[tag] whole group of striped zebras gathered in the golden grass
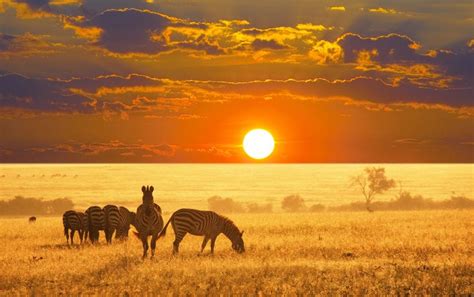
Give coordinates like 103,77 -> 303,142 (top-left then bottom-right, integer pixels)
63,186 -> 245,258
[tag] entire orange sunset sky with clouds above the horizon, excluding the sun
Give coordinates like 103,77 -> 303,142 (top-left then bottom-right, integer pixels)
0,0 -> 474,162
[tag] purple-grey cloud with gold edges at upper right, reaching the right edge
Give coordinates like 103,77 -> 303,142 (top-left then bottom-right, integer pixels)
337,33 -> 474,88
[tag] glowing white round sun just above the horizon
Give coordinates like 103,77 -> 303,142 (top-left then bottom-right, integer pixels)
243,129 -> 275,160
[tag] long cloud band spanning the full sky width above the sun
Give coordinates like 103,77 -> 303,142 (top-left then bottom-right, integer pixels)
0,74 -> 473,119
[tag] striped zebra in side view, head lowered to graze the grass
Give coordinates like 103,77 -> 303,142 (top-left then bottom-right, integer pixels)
158,208 -> 245,254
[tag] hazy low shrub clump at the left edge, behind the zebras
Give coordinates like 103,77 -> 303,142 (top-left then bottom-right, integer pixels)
0,196 -> 74,215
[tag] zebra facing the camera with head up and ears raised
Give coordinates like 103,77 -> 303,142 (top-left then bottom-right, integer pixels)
134,186 -> 163,258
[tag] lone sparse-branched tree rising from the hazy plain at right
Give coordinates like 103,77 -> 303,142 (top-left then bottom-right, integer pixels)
351,167 -> 395,212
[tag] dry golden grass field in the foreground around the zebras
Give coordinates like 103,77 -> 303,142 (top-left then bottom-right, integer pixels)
0,211 -> 474,296
